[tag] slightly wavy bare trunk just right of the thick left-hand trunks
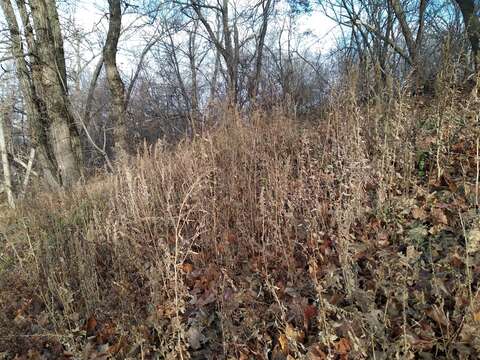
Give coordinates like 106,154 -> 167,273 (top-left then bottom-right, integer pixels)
103,0 -> 128,156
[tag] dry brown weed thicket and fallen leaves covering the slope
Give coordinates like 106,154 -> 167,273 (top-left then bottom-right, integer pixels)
0,74 -> 480,359
